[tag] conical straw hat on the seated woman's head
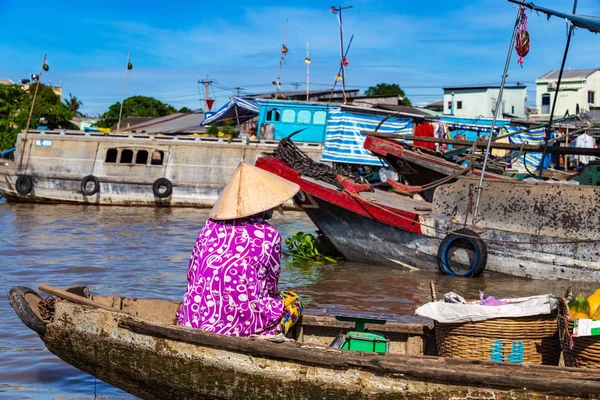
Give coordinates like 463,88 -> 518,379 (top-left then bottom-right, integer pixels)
210,162 -> 300,220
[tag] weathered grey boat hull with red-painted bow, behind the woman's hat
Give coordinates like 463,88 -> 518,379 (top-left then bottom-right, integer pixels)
256,153 -> 600,281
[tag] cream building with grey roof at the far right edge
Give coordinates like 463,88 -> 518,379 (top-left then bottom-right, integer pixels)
535,68 -> 600,116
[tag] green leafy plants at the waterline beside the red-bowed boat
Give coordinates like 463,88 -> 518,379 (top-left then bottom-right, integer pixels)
285,231 -> 344,264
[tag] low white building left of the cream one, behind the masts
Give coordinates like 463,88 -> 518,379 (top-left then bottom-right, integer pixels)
444,85 -> 527,118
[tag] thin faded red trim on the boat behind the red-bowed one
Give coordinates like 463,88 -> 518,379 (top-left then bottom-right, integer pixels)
364,136 -> 513,180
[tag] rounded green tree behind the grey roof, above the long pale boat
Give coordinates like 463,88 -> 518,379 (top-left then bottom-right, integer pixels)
96,96 -> 176,128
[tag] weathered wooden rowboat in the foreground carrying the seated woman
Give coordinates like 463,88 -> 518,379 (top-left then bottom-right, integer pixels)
9,287 -> 600,400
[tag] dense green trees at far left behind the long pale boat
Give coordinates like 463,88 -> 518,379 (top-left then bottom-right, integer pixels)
0,83 -> 73,150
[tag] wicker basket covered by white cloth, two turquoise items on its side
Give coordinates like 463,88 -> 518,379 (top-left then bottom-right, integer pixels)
435,315 -> 560,365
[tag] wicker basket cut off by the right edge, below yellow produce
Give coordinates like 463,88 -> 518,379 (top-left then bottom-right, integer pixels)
558,299 -> 600,369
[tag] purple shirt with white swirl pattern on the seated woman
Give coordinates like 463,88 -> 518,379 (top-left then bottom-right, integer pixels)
177,217 -> 283,336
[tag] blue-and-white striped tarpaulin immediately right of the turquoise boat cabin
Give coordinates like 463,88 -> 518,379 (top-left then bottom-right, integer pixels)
323,109 -> 413,166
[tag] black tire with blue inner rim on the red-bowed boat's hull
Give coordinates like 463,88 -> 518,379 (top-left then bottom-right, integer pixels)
437,228 -> 488,278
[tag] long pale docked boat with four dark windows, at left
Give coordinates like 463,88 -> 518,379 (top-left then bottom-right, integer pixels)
0,131 -> 323,207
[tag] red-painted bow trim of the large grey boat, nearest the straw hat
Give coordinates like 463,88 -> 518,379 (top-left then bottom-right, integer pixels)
256,156 -> 423,234
